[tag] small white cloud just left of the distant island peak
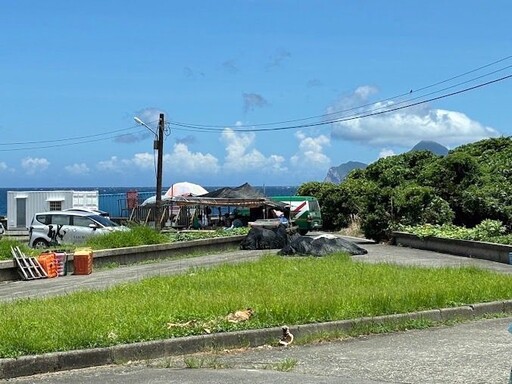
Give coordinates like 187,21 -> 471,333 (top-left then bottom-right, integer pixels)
290,131 -> 331,167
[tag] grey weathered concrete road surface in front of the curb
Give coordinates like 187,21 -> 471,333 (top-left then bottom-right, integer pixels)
7,318 -> 512,384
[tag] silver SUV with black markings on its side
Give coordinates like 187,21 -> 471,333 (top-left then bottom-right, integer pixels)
28,211 -> 128,248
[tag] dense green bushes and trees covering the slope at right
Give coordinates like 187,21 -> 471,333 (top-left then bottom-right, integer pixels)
297,137 -> 512,241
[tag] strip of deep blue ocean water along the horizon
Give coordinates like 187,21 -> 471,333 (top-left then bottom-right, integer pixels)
0,186 -> 298,216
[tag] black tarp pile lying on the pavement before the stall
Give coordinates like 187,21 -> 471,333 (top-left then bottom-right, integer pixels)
240,225 -> 368,256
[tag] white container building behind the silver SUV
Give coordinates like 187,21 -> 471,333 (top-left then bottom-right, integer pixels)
7,190 -> 99,230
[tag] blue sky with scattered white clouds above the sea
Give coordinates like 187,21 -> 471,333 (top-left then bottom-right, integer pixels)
0,0 -> 512,188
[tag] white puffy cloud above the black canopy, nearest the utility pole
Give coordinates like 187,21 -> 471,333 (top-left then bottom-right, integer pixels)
221,128 -> 287,173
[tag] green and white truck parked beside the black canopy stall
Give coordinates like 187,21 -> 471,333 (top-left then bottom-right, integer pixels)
270,196 -> 322,235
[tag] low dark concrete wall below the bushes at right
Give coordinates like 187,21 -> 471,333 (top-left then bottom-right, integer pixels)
392,232 -> 512,264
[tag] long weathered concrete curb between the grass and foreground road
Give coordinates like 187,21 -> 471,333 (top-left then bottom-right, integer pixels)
0,300 -> 512,379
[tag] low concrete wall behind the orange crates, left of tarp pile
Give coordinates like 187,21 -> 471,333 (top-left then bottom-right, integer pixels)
0,235 -> 245,281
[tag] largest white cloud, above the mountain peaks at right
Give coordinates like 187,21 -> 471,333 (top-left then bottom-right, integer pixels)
328,87 -> 499,147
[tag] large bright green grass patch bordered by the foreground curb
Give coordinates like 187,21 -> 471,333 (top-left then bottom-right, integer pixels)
0,254 -> 512,357
